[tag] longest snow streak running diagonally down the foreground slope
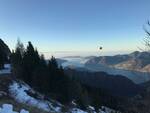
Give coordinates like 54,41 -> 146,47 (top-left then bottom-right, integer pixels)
9,82 -> 61,112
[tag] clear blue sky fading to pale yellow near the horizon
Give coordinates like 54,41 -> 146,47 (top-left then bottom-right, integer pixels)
0,0 -> 150,57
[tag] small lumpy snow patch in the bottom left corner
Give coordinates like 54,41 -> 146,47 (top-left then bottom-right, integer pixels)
0,104 -> 29,113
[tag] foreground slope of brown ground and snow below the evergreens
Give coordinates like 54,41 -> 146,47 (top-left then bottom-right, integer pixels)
0,75 -> 120,113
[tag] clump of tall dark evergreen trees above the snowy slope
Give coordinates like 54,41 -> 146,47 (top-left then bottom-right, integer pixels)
11,41 -> 81,103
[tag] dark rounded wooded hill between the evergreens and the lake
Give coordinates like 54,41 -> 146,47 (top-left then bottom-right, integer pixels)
66,69 -> 143,96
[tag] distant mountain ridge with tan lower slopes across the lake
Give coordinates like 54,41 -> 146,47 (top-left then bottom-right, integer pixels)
86,51 -> 150,72
